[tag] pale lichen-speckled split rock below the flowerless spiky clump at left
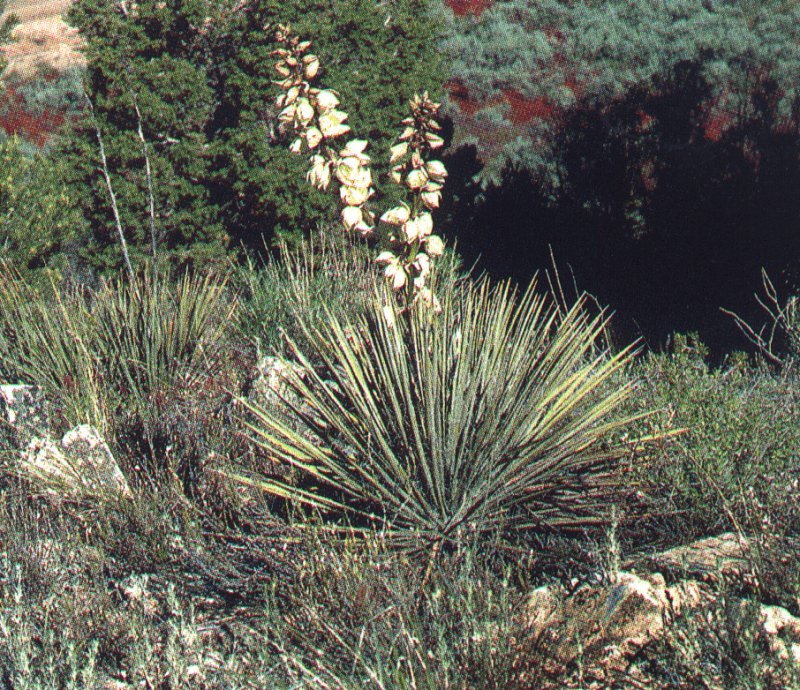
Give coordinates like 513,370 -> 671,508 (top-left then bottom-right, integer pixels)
21,424 -> 131,499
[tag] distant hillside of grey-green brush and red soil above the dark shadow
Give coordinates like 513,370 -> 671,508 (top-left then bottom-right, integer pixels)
443,0 -> 800,188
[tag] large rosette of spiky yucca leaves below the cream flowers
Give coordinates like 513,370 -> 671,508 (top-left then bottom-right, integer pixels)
237,281 -> 630,551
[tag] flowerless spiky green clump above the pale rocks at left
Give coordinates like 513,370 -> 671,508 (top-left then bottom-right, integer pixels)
0,266 -> 236,438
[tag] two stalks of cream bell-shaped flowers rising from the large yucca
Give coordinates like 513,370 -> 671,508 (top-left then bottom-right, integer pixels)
272,25 -> 447,312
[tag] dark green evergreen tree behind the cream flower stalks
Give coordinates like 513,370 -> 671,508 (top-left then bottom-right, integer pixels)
58,0 -> 444,270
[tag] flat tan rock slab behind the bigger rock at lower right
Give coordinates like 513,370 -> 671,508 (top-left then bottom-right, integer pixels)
636,532 -> 750,582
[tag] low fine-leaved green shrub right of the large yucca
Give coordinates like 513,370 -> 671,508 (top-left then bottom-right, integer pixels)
630,336 -> 800,541
